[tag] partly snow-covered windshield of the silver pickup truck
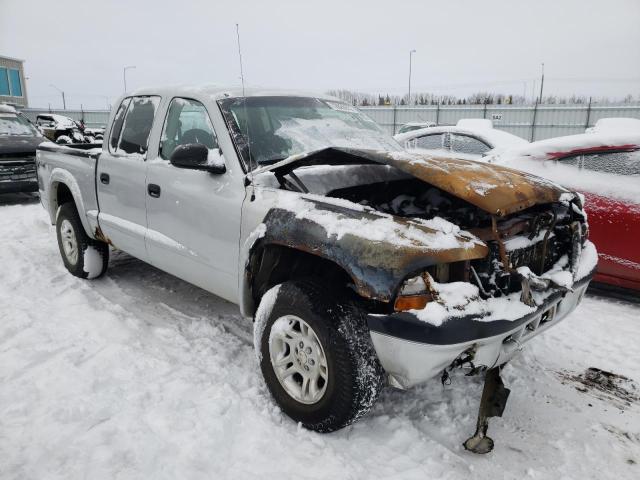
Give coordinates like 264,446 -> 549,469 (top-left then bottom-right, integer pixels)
219,96 -> 401,169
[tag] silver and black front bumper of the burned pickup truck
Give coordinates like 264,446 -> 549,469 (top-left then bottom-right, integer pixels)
367,269 -> 595,388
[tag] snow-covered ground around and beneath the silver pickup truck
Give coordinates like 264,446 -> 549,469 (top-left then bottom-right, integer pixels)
0,197 -> 640,480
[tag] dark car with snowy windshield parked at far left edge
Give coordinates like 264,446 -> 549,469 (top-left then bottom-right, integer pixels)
0,105 -> 46,194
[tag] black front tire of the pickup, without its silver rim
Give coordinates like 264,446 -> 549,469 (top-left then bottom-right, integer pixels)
254,280 -> 384,432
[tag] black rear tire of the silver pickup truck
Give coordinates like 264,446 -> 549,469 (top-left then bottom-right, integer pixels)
56,203 -> 109,279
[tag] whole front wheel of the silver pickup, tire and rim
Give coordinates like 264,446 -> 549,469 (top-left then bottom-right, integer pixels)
254,281 -> 383,432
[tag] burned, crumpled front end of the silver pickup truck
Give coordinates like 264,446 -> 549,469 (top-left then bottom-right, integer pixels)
248,148 -> 597,453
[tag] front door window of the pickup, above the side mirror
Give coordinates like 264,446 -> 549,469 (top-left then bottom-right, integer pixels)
160,98 -> 218,160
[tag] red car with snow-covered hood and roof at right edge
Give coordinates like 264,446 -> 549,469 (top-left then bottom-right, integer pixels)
488,125 -> 640,296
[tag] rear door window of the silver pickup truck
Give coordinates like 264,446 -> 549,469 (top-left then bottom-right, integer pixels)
112,96 -> 160,155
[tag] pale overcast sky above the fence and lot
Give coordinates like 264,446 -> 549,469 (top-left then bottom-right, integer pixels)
0,0 -> 640,108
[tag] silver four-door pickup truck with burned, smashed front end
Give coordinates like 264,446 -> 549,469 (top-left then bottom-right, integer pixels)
36,87 -> 597,451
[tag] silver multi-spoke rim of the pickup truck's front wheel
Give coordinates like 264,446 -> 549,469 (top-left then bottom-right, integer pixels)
269,315 -> 329,405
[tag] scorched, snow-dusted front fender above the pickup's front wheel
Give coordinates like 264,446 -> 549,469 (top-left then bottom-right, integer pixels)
245,198 -> 488,316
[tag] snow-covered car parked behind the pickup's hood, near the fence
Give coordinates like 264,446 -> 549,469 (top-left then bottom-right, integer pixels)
394,118 -> 529,160
